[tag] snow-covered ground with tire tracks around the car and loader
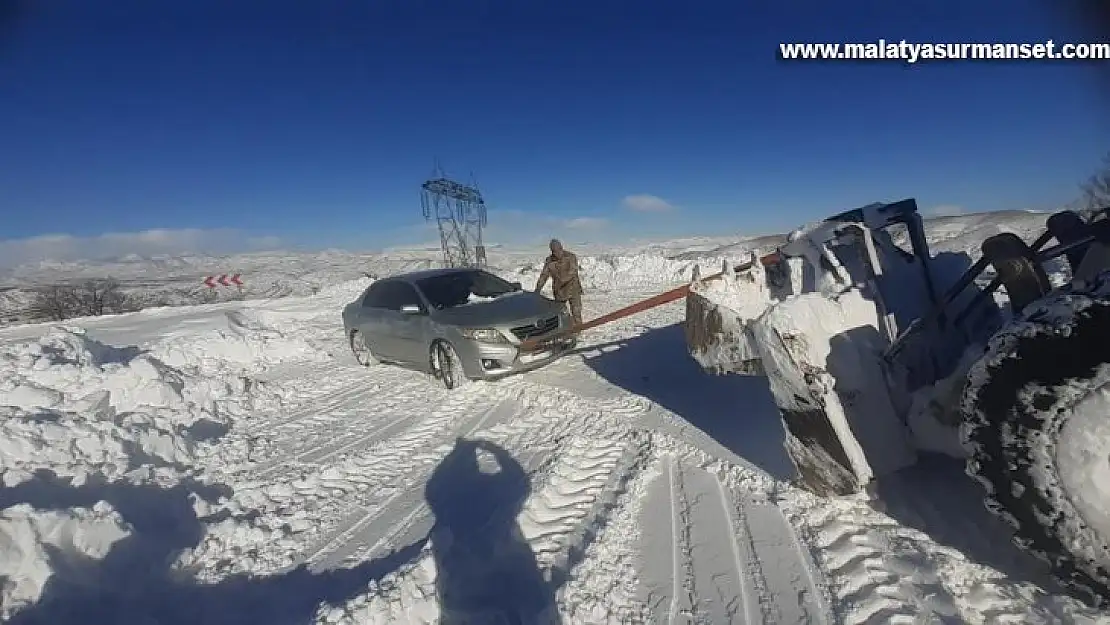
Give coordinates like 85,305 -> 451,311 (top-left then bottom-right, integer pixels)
0,213 -> 1110,625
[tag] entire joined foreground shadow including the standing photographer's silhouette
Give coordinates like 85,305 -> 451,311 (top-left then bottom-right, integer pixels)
0,438 -> 558,625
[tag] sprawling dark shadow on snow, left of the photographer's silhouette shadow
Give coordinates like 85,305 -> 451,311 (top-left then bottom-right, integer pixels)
0,474 -> 423,625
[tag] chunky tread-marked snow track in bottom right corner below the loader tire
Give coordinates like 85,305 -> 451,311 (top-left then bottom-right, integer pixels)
794,484 -> 1110,625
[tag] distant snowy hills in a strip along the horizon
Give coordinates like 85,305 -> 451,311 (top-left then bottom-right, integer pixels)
0,211 -> 1043,327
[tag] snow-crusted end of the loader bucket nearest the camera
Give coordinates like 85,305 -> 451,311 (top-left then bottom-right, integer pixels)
748,289 -> 917,495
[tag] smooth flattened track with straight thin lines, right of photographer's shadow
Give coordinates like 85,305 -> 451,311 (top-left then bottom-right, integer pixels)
639,444 -> 829,625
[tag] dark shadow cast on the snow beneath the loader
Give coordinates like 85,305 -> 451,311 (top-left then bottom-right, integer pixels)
576,324 -> 1063,594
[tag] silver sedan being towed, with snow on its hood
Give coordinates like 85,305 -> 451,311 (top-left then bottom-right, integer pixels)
343,269 -> 574,389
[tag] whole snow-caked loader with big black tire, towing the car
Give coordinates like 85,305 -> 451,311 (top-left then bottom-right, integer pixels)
686,199 -> 1110,605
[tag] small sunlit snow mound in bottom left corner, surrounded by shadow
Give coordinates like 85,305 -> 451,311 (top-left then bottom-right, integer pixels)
0,502 -> 131,619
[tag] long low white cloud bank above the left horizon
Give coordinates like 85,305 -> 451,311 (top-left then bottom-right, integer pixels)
0,228 -> 281,266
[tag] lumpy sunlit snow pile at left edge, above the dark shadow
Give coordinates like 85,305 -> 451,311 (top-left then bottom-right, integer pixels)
0,329 -> 275,486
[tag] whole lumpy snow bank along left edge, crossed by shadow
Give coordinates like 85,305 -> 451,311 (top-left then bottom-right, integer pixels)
0,327 -> 295,617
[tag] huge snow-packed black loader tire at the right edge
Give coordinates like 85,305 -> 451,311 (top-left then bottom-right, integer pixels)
960,273 -> 1110,607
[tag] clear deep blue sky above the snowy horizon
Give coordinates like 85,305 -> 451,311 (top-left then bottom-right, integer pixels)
0,0 -> 1110,261
